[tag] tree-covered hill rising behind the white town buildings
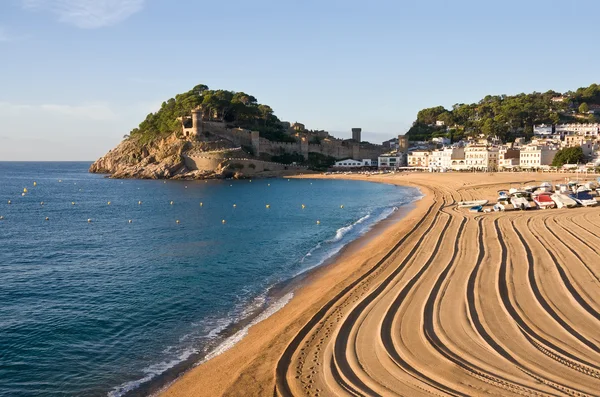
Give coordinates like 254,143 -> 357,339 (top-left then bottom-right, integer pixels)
407,84 -> 600,141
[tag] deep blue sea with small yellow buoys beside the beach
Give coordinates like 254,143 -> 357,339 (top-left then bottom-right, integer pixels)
0,162 -> 420,396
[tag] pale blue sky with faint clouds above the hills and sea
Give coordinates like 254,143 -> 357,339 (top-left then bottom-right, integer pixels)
0,0 -> 600,160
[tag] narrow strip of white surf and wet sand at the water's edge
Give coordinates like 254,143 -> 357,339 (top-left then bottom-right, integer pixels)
122,180 -> 424,397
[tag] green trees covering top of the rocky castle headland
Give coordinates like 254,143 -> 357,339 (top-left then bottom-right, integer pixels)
130,84 -> 293,143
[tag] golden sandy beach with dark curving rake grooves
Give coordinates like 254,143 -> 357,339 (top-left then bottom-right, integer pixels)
162,173 -> 600,397
